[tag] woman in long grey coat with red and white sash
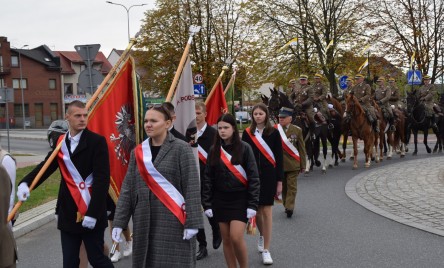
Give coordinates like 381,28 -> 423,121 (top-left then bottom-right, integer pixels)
112,106 -> 203,267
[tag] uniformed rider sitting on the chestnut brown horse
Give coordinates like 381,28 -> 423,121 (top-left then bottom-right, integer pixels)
350,74 -> 379,133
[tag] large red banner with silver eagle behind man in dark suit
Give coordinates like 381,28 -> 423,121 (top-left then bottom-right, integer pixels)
88,57 -> 144,201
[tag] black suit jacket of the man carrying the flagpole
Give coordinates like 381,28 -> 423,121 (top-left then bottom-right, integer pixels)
20,129 -> 110,233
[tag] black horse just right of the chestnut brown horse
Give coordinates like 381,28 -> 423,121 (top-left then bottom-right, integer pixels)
407,90 -> 442,155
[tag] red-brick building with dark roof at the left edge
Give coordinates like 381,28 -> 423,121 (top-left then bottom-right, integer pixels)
0,37 -> 62,128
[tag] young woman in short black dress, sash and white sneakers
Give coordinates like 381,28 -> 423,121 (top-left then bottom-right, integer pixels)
242,103 -> 284,264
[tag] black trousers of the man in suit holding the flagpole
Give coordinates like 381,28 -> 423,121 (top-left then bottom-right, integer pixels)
60,229 -> 114,268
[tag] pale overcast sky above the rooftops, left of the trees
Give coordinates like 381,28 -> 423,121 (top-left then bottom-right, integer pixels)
0,0 -> 155,57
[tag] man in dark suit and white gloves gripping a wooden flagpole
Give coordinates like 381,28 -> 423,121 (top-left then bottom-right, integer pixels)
17,101 -> 114,267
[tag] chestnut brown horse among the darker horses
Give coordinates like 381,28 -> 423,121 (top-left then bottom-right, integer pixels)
345,94 -> 377,169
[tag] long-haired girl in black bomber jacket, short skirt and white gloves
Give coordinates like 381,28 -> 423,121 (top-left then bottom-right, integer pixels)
202,114 -> 260,268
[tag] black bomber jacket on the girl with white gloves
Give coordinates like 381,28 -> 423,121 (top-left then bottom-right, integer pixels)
202,141 -> 260,211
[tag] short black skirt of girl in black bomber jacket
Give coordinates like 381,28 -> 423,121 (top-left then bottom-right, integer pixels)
213,191 -> 248,223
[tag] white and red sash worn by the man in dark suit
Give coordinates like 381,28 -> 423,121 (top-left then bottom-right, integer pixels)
57,135 -> 93,216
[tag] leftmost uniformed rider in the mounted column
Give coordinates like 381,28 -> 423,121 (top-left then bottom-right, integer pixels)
290,74 -> 316,138
